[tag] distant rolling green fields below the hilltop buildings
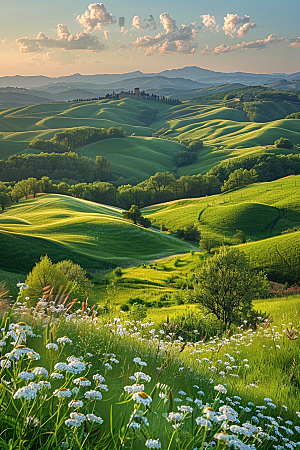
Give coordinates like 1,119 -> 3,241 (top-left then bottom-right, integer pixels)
0,99 -> 300,181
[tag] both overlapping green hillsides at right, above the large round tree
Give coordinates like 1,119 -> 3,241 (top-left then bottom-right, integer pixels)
143,176 -> 300,281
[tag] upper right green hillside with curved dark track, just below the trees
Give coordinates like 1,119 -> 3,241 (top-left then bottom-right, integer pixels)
143,176 -> 300,240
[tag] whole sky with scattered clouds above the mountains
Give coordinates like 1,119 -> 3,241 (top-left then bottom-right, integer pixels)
0,0 -> 300,77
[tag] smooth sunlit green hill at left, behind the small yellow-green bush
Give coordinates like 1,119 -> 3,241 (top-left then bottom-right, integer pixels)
0,195 -> 196,272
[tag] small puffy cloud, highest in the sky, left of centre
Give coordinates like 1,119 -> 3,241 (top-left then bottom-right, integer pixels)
77,3 -> 116,33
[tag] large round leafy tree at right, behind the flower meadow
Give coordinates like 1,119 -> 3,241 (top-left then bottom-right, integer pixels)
194,246 -> 268,327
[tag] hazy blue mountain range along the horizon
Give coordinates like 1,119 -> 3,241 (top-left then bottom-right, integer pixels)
0,66 -> 300,109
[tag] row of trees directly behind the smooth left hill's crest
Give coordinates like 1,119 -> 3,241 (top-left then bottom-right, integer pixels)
0,172 -> 221,209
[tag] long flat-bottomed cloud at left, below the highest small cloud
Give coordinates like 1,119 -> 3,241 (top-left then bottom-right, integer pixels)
16,24 -> 105,53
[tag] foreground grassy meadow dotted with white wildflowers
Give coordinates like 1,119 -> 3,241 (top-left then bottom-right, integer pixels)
0,291 -> 300,450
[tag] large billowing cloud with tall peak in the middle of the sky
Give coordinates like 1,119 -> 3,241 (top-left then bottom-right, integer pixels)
132,13 -> 198,56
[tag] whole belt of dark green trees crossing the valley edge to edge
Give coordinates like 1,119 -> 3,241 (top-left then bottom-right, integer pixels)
0,152 -> 300,209
